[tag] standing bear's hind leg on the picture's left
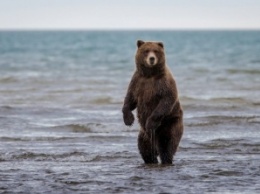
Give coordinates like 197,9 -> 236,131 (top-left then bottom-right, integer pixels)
138,130 -> 158,164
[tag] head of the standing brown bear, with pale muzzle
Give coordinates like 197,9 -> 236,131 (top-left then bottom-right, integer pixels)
135,40 -> 165,75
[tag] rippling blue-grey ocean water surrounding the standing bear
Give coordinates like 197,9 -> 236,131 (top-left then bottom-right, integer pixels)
0,31 -> 260,193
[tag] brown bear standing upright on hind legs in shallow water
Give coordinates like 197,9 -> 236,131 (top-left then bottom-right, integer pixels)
122,40 -> 183,164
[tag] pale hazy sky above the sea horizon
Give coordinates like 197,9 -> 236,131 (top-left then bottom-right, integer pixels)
0,0 -> 260,29
